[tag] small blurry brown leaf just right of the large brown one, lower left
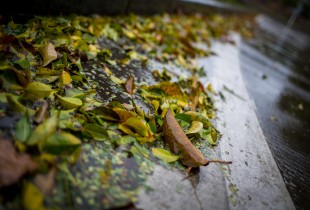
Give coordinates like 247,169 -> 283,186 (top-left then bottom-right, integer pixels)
34,167 -> 57,196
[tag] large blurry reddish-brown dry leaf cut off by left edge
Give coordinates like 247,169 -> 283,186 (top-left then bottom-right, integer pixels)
0,138 -> 38,187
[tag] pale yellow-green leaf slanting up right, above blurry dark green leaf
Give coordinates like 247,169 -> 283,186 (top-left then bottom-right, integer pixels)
27,115 -> 58,145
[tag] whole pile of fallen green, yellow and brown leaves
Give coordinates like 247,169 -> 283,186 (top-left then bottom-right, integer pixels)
0,15 -> 249,210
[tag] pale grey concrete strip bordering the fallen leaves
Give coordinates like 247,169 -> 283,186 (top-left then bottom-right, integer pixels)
137,35 -> 295,210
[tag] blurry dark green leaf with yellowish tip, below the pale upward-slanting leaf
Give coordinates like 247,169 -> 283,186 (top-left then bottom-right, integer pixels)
42,131 -> 81,155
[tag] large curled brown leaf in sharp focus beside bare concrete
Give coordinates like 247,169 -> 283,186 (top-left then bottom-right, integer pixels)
163,109 -> 208,167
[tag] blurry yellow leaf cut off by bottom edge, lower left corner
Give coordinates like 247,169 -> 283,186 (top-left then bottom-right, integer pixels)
23,182 -> 45,210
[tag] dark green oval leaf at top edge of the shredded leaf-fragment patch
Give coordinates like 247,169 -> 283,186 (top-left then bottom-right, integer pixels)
82,123 -> 109,141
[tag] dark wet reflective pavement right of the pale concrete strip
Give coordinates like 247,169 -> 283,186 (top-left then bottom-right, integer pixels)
240,15 -> 310,209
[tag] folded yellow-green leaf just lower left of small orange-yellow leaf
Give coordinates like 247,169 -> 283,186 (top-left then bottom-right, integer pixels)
24,82 -> 53,100
